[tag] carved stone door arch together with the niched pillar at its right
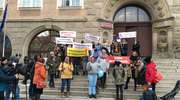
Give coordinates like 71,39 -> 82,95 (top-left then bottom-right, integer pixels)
100,0 -> 174,57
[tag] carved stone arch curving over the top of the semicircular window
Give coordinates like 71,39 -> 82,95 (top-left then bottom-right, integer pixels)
103,0 -> 171,20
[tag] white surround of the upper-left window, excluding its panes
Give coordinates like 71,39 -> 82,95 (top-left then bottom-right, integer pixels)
17,0 -> 43,10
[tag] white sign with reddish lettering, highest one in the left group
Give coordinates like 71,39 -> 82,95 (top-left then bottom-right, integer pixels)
60,31 -> 76,38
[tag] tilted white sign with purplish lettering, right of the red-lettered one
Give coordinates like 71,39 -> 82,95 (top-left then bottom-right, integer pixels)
85,33 -> 100,42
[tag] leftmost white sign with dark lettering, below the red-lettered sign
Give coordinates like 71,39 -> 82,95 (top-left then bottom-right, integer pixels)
56,37 -> 73,44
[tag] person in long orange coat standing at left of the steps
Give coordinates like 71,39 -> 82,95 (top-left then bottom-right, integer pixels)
33,58 -> 46,100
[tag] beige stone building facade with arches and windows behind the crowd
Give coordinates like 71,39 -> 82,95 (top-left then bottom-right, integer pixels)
0,0 -> 180,58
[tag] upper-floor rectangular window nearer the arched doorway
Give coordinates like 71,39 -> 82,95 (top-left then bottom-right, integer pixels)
57,0 -> 84,8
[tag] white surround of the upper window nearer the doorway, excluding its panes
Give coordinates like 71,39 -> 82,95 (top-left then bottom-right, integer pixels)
57,0 -> 84,9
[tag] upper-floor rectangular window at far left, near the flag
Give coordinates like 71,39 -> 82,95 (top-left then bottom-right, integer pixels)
18,0 -> 43,8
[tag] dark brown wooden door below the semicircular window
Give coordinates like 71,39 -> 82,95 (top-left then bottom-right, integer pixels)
114,23 -> 152,56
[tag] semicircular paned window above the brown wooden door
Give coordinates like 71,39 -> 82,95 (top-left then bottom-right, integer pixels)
114,6 -> 151,22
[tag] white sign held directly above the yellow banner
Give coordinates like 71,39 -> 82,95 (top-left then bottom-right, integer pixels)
73,43 -> 92,50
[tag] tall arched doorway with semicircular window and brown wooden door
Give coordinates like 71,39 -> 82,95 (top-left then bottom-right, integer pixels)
113,5 -> 152,56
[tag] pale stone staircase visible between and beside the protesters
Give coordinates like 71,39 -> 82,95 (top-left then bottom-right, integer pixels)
20,59 -> 180,100
